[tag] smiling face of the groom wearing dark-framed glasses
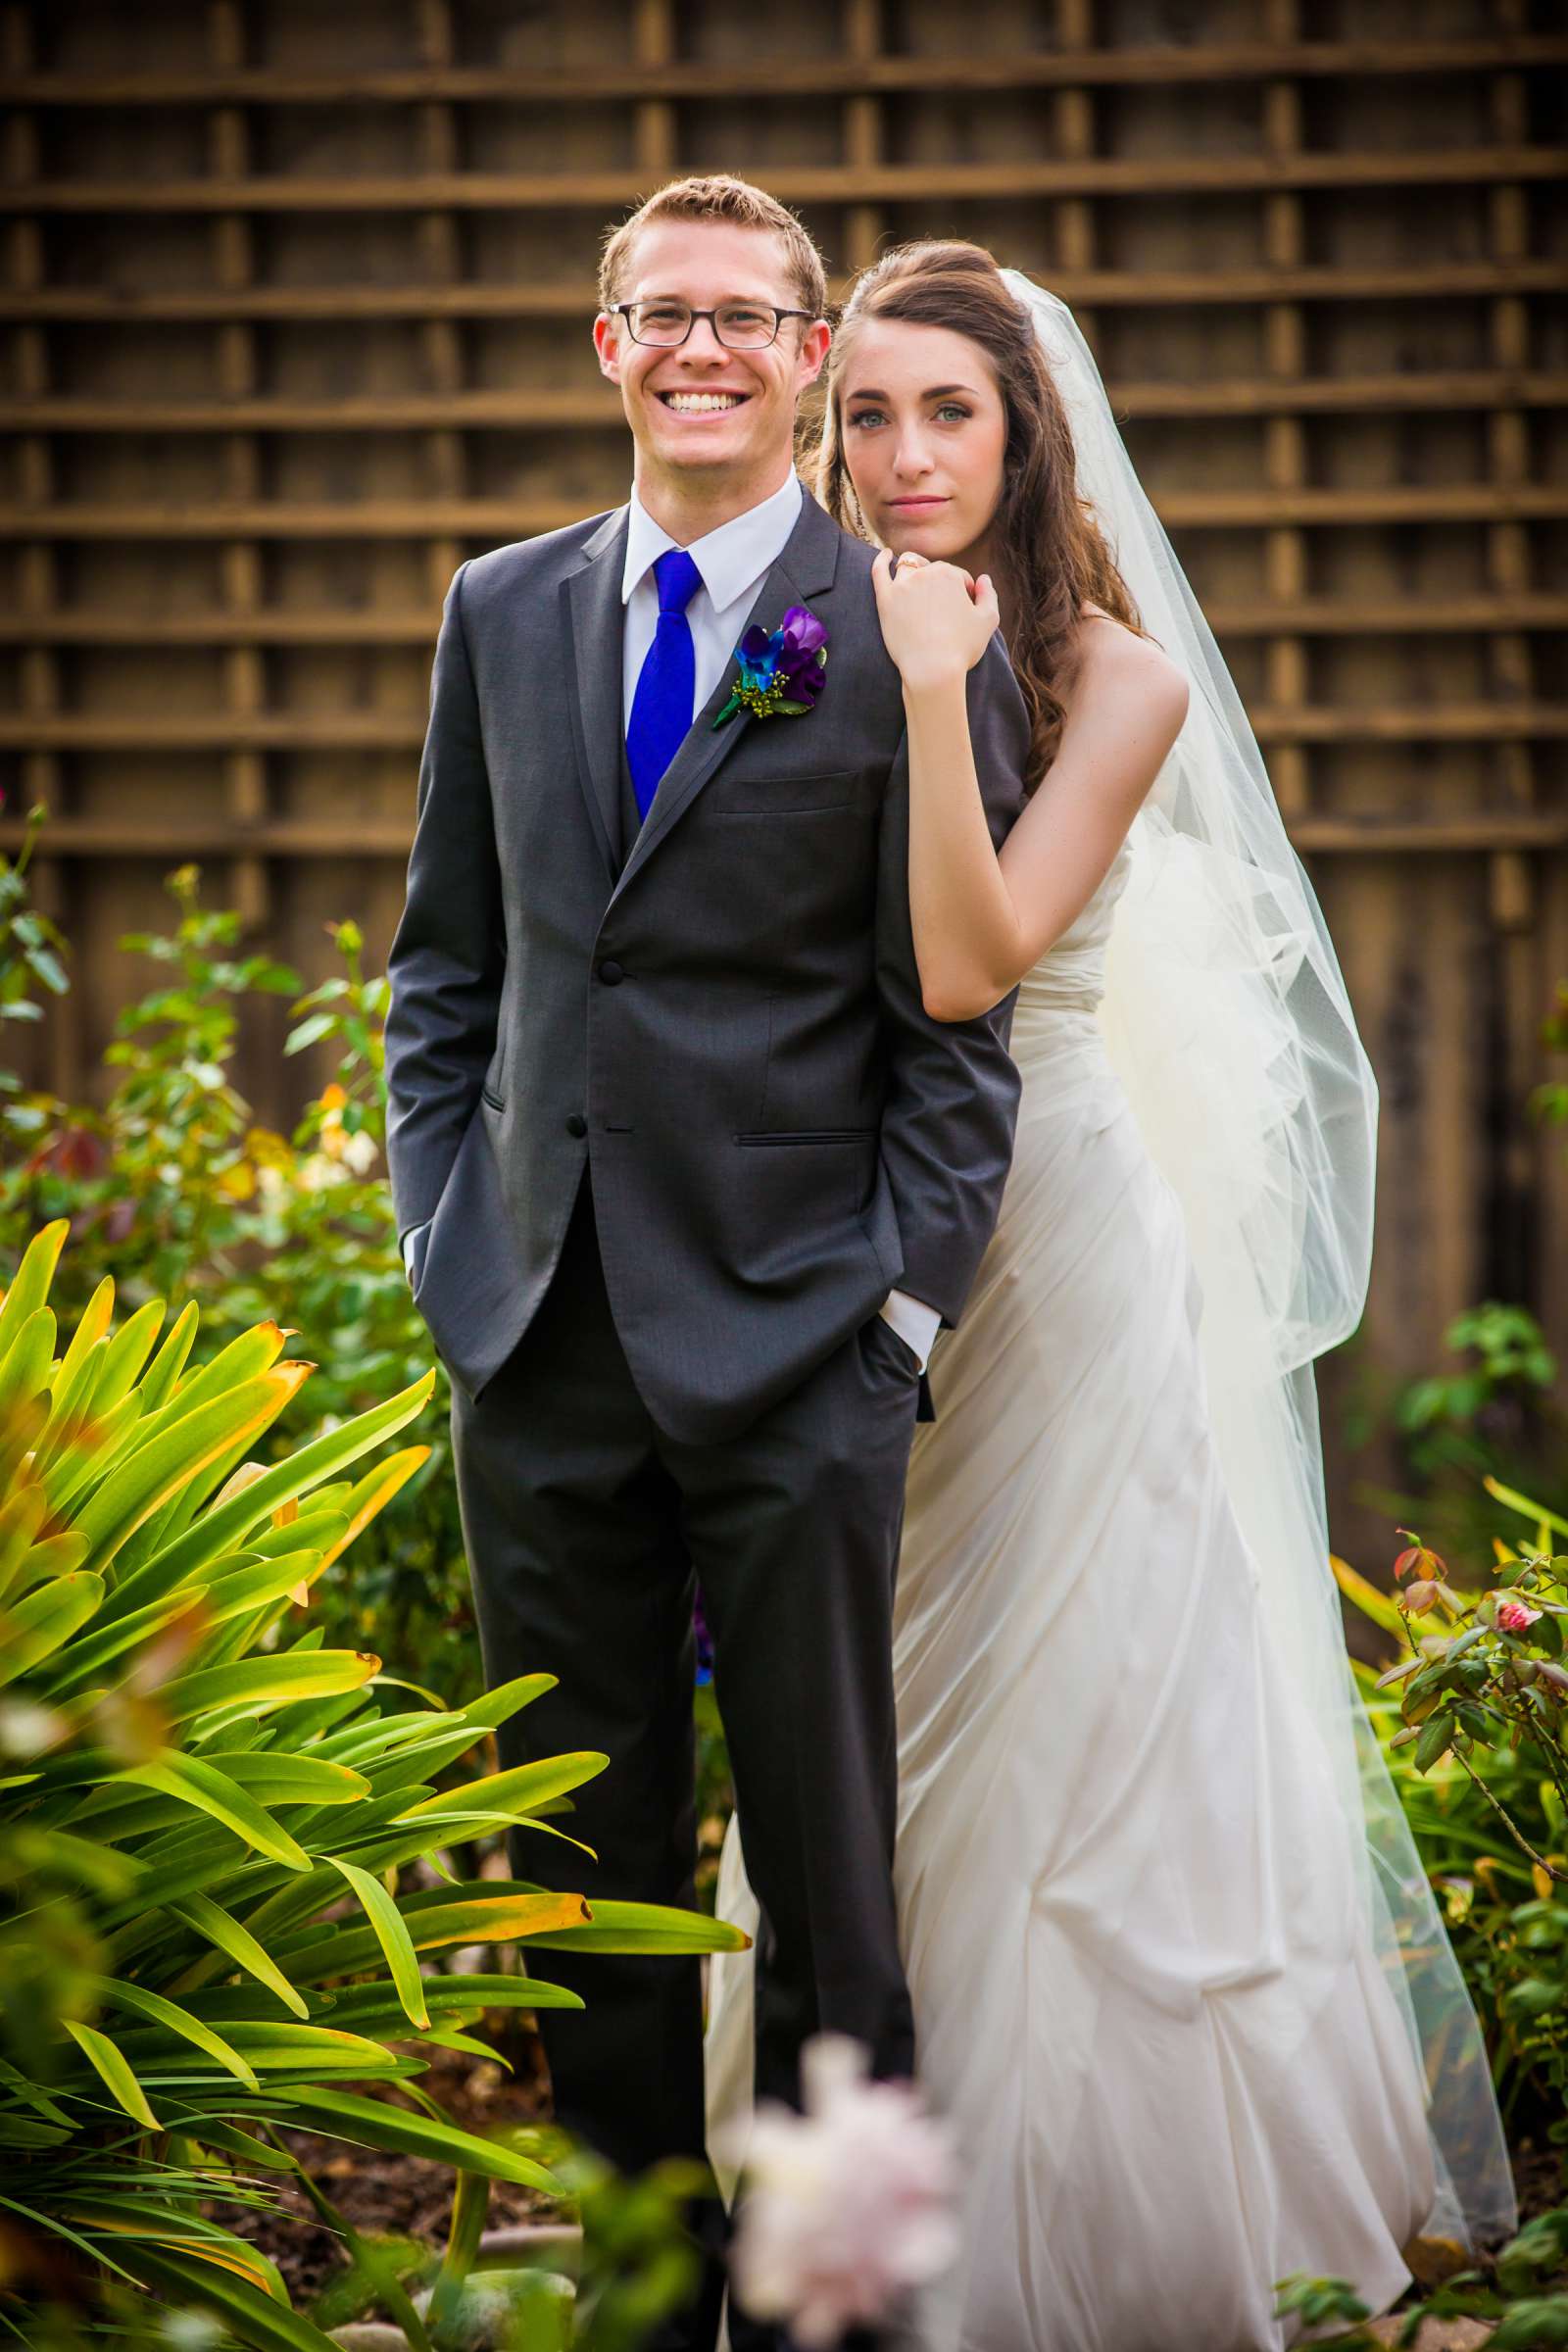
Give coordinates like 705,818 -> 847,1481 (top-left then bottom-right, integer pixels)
592,221 -> 830,482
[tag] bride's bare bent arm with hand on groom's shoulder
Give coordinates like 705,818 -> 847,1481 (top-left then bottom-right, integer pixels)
877,558 -> 1187,1021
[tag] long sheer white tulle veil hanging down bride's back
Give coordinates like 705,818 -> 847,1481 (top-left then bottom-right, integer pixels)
1002,270 -> 1514,2244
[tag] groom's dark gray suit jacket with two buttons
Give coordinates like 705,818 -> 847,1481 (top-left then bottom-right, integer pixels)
385,499 -> 1027,1445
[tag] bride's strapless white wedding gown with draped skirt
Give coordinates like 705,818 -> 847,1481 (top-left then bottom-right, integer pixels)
708,849 -> 1434,2352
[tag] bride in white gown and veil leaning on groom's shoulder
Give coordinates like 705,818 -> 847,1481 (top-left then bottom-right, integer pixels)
708,245 -> 1514,2352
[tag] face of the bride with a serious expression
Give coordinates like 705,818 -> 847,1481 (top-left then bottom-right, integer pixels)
839,318 -> 1006,569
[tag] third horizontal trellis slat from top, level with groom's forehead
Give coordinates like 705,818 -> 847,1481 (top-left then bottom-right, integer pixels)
0,259 -> 1563,324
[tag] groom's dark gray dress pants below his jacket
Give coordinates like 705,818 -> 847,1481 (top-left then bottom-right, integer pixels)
452,1178 -> 919,2352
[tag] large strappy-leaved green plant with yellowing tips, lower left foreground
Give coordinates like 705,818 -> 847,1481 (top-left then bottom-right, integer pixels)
0,1221 -> 738,2352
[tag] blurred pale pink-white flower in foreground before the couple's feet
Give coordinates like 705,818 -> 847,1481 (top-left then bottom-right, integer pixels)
731,2034 -> 959,2347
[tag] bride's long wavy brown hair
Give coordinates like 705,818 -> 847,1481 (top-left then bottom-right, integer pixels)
818,240 -> 1145,790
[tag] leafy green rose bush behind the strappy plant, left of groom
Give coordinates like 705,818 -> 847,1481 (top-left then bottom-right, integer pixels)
0,860 -> 479,1703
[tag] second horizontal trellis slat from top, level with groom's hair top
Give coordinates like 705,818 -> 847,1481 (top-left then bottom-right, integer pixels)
0,146 -> 1568,214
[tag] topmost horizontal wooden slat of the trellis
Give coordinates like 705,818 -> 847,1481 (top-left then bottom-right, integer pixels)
10,33 -> 1568,108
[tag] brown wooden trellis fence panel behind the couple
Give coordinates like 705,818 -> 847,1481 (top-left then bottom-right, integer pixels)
0,0 -> 1568,1534
